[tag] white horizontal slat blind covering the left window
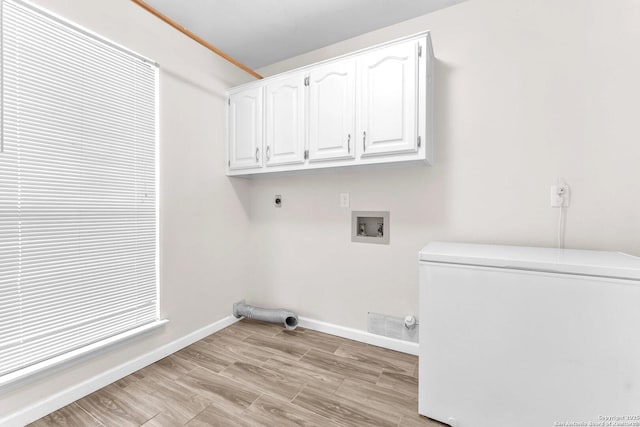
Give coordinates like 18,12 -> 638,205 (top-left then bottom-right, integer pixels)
0,0 -> 158,378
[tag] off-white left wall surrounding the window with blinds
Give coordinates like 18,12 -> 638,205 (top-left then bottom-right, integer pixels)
0,0 -> 255,424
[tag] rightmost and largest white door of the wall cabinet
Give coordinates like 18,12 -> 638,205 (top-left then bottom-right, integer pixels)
358,41 -> 418,157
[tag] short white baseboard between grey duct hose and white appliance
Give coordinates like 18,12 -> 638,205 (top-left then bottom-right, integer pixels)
298,317 -> 420,356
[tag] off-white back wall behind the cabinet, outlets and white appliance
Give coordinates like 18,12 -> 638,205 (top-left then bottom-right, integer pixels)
250,0 -> 640,329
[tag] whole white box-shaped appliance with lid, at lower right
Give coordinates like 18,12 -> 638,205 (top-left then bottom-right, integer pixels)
419,242 -> 640,427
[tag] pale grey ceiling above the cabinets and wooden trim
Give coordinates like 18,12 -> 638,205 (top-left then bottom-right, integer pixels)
146,0 -> 463,69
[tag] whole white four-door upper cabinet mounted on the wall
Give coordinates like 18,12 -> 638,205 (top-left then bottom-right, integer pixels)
227,32 -> 434,176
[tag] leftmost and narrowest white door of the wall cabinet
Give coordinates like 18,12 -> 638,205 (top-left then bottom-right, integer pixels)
229,87 -> 262,169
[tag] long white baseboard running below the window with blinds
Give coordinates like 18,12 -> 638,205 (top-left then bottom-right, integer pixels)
0,316 -> 240,427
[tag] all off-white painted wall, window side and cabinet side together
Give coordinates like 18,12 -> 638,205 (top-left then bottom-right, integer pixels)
0,0 -> 640,419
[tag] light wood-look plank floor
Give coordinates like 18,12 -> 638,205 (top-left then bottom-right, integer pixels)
31,319 -> 444,427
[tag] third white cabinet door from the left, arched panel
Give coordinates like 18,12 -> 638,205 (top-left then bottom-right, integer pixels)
309,60 -> 356,161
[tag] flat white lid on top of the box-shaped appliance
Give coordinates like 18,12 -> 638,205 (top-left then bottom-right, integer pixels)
420,242 -> 640,280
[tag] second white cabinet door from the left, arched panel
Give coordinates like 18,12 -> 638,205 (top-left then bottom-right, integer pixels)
265,74 -> 305,166
